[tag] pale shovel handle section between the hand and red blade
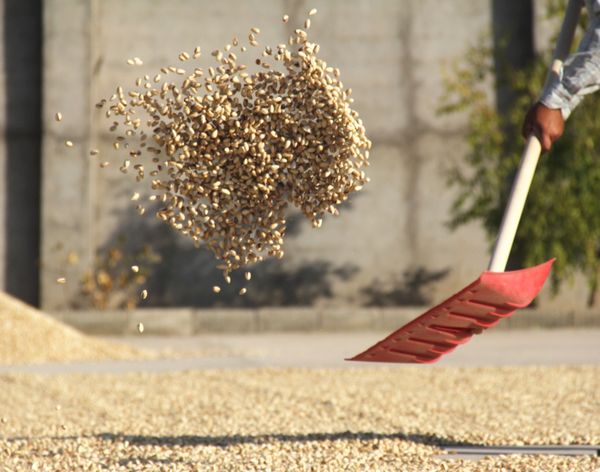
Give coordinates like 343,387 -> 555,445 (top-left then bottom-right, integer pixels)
488,135 -> 542,272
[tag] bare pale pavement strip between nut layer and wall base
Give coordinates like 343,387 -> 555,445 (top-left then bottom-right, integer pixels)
0,329 -> 600,374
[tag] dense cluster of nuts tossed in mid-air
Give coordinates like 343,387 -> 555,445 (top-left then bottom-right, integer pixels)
95,9 -> 371,276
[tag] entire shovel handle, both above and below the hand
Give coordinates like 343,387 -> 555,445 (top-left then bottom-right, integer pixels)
488,0 -> 583,272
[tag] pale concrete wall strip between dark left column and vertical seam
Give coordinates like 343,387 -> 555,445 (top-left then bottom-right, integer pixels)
40,0 -> 99,307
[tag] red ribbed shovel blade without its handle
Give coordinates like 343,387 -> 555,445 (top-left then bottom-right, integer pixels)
347,259 -> 554,363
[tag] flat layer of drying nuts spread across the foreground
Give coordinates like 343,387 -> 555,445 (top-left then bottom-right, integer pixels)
0,367 -> 600,471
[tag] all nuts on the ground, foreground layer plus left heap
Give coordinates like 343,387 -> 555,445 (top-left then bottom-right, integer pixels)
0,296 -> 600,471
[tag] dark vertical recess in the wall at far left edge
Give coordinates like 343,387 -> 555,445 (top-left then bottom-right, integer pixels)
1,0 -> 42,305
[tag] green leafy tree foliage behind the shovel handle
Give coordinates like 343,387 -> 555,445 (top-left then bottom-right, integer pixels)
441,1 -> 600,305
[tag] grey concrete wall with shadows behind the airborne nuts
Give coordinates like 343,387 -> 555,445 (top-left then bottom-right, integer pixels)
41,0 -> 592,309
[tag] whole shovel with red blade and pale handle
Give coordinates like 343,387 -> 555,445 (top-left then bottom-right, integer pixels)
347,0 -> 582,363
